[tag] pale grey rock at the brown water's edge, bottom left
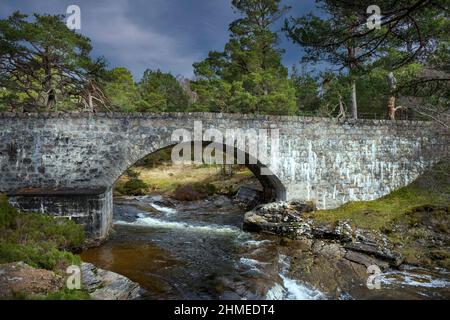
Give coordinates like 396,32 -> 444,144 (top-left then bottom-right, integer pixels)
81,263 -> 144,300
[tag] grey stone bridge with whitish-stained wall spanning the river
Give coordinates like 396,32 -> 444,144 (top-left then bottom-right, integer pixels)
0,113 -> 449,239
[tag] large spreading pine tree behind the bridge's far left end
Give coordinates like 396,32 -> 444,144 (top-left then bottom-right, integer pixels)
0,12 -> 104,112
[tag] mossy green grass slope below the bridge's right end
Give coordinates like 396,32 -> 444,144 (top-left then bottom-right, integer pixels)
306,162 -> 450,269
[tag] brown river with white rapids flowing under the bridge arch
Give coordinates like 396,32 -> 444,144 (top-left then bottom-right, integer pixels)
82,196 -> 450,299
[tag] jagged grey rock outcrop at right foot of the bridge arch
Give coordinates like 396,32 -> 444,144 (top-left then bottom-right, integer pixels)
244,201 -> 403,268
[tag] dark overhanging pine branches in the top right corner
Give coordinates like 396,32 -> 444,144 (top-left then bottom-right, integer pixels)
283,0 -> 449,69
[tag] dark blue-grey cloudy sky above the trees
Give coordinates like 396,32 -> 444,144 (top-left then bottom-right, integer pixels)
0,0 -> 315,80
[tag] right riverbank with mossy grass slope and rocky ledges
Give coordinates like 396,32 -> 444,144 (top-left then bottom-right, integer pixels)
244,164 -> 450,297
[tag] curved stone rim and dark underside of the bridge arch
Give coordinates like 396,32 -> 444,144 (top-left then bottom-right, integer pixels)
113,139 -> 286,202
